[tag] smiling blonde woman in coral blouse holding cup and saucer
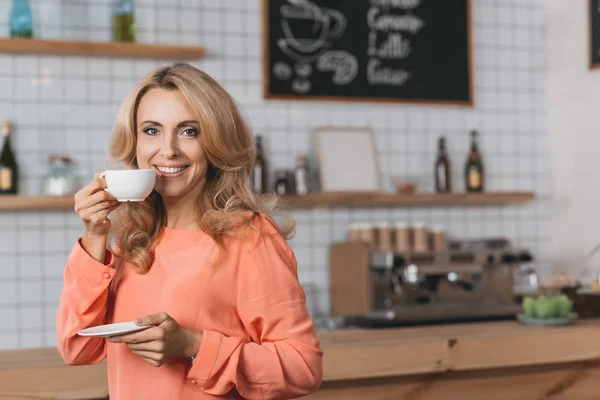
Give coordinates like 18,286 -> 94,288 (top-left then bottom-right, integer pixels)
57,64 -> 322,400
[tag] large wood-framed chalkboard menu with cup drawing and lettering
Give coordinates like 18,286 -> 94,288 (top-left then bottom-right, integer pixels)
263,0 -> 474,105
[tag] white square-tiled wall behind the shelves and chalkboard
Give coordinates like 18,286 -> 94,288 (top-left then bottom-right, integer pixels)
0,0 -> 550,348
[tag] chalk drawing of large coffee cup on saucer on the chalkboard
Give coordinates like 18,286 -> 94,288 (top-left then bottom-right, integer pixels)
277,0 -> 346,61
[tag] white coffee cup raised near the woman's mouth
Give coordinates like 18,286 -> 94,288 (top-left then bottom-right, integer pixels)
100,169 -> 156,201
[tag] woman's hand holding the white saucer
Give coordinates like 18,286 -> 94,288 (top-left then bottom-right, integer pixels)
108,312 -> 202,367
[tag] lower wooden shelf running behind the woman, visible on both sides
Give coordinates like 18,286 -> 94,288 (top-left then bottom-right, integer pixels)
0,192 -> 535,210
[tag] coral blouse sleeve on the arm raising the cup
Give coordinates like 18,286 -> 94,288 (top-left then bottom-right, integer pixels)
56,239 -> 116,365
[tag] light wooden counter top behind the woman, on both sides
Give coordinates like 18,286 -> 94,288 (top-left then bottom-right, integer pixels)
0,319 -> 600,399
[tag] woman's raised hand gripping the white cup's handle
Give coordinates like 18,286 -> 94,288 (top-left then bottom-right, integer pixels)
75,173 -> 121,238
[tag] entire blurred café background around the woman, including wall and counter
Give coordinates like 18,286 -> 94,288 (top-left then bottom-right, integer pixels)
5,0 -> 600,400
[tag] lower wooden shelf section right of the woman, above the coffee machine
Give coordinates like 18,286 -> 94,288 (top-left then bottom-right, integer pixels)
281,192 -> 535,208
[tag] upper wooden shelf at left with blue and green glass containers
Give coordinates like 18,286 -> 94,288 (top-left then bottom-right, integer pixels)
0,0 -> 206,60
